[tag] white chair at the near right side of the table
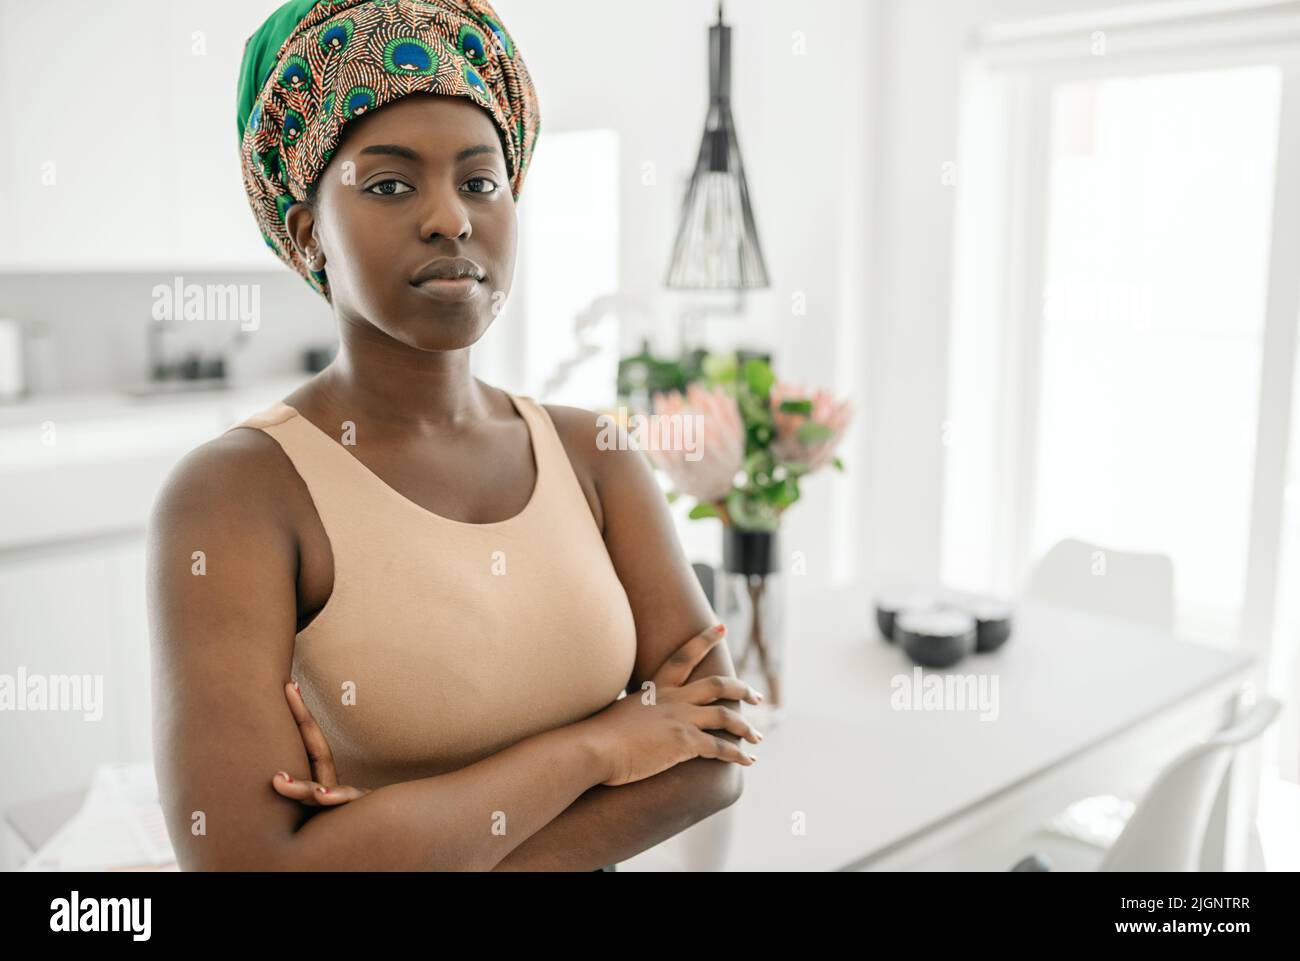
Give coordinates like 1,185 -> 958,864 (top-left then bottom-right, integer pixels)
1011,697 -> 1282,871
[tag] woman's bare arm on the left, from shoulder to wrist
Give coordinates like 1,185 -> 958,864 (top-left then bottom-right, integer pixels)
148,430 -> 611,870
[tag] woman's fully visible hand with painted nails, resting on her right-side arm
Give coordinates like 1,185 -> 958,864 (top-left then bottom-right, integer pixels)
584,624 -> 763,785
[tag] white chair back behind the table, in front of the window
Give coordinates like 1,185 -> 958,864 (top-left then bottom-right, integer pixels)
1024,537 -> 1174,632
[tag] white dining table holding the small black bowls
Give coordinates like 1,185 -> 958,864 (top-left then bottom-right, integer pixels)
619,584 -> 1253,871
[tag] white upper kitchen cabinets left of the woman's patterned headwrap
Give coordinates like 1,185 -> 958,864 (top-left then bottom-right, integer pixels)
0,0 -> 278,272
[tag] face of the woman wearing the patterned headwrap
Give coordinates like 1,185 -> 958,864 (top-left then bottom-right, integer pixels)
289,95 -> 517,350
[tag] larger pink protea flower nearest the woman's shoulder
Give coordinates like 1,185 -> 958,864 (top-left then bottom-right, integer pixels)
646,384 -> 745,503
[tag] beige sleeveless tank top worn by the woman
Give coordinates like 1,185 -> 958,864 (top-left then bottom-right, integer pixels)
230,391 -> 636,789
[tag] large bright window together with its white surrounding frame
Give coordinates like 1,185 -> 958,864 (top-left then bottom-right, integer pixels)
941,3 -> 1300,779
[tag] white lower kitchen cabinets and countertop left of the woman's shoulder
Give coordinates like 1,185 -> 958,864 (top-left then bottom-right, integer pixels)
0,375 -> 307,847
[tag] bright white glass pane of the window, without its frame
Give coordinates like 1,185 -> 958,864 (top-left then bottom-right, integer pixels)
1027,66 -> 1281,638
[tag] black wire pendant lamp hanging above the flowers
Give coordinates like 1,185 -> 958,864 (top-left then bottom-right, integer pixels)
664,3 -> 767,290
